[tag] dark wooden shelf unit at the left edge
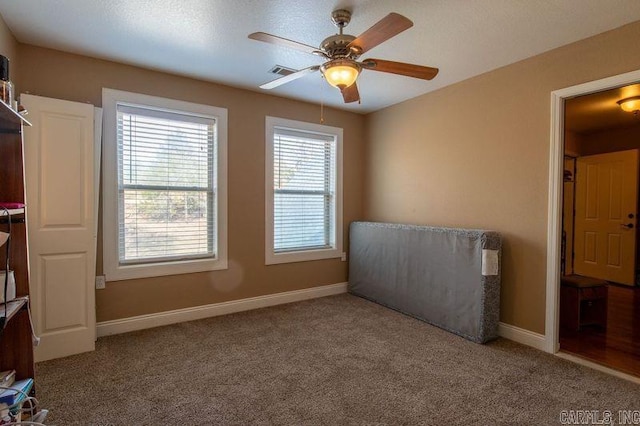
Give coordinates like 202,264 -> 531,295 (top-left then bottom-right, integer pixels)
0,101 -> 34,380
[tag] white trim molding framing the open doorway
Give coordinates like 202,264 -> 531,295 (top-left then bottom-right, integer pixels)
543,70 -> 640,354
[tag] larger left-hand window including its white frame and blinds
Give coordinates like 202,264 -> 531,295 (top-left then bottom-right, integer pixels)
103,89 -> 226,281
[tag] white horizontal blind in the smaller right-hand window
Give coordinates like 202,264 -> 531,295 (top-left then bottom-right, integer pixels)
273,127 -> 337,253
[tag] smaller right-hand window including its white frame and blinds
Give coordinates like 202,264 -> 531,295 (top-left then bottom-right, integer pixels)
266,117 -> 342,264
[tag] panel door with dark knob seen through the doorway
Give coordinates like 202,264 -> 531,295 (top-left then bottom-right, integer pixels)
574,149 -> 638,285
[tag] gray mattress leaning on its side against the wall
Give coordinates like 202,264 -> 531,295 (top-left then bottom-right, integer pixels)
349,222 -> 502,343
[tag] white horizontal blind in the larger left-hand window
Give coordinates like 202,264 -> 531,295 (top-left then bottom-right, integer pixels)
117,104 -> 217,265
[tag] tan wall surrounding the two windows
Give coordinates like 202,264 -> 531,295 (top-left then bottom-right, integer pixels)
19,45 -> 364,321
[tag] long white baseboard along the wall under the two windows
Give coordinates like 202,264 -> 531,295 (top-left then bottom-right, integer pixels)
97,283 -> 347,337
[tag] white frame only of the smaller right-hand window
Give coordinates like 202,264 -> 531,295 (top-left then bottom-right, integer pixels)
265,116 -> 343,265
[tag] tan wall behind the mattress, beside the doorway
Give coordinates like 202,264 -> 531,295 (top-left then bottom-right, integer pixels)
365,22 -> 640,333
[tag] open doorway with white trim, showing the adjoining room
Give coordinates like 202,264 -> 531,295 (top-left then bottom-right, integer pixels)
545,72 -> 640,377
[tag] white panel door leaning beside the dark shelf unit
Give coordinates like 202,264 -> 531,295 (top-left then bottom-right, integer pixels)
20,95 -> 97,361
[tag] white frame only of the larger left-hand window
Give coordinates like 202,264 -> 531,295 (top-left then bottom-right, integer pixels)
102,88 -> 228,281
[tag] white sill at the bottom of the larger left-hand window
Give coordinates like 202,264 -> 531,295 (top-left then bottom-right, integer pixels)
104,259 -> 228,281
